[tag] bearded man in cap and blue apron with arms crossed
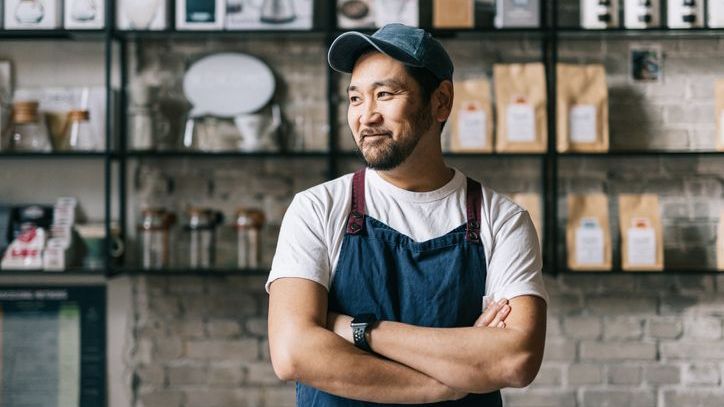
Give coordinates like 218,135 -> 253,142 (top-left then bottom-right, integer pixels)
266,24 -> 547,407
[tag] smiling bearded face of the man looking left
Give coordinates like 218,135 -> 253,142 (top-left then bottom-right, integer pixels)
347,52 -> 434,170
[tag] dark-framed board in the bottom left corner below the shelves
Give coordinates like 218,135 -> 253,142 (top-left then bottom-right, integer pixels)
0,286 -> 106,407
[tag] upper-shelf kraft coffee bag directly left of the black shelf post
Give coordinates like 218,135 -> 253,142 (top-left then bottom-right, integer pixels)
493,63 -> 548,153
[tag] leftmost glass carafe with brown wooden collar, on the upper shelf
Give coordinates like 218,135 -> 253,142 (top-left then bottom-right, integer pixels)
6,101 -> 53,153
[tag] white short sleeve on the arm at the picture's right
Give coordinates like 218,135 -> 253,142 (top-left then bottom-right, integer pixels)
486,211 -> 548,303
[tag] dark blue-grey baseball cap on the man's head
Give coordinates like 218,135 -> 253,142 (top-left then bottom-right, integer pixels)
327,23 -> 453,80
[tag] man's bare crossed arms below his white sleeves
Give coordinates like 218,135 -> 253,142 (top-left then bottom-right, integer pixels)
269,278 -> 546,404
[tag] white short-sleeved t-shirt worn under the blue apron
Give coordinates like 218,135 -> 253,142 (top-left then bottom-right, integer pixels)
266,169 -> 548,302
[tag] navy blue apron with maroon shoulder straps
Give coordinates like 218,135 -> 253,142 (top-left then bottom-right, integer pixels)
297,169 -> 502,407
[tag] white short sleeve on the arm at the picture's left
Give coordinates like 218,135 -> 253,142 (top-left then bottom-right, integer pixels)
265,193 -> 330,293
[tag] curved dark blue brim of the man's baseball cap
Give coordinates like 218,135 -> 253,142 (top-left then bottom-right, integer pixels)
327,31 -> 422,73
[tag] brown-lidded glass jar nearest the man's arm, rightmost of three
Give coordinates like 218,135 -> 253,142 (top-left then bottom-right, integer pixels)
236,208 -> 265,269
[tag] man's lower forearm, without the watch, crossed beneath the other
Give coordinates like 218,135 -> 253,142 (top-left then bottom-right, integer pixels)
272,326 -> 462,404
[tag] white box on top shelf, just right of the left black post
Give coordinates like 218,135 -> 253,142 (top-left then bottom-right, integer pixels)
116,0 -> 170,31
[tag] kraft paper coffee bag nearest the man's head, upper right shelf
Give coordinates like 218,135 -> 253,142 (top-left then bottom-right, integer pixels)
450,78 -> 493,153
